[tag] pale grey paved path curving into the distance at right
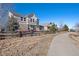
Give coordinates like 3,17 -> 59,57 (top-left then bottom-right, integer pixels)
48,33 -> 79,56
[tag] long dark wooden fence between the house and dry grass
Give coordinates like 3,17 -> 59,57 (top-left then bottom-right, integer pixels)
0,31 -> 51,40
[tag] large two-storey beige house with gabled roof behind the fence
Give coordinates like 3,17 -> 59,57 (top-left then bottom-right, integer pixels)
9,12 -> 39,31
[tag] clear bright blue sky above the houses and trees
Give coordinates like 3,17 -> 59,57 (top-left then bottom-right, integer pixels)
13,3 -> 79,28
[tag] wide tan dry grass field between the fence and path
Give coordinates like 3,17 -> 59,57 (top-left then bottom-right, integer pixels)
0,34 -> 54,56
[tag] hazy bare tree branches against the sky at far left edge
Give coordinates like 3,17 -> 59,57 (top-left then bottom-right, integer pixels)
0,3 -> 13,29
